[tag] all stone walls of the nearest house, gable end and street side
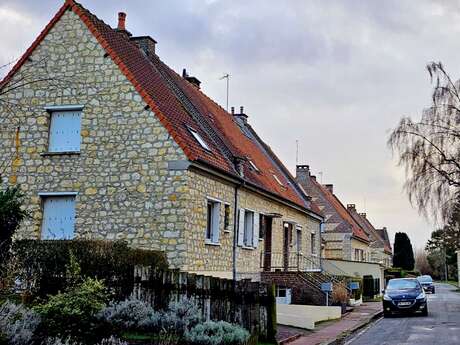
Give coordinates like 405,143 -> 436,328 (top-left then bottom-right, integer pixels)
0,11 -> 320,277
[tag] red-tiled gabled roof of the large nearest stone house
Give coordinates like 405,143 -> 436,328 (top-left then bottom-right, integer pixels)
0,0 -> 322,215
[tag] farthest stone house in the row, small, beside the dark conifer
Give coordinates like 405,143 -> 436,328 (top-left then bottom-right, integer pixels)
347,204 -> 393,268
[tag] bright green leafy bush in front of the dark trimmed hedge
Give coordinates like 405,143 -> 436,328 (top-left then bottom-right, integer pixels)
34,278 -> 108,344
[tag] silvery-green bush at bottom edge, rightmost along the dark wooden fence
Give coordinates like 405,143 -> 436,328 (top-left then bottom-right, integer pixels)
185,321 -> 250,345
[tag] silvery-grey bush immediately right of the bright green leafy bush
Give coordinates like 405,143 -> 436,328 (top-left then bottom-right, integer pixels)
98,297 -> 161,331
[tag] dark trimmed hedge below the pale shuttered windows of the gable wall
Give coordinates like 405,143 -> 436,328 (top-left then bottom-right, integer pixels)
12,240 -> 168,299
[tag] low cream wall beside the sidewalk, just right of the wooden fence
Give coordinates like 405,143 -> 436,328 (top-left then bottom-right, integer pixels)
276,304 -> 342,329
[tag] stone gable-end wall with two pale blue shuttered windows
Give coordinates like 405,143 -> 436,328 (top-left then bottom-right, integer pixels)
0,11 -> 186,265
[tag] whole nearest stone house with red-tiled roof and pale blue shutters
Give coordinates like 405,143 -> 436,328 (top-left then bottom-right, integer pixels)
0,0 -> 323,279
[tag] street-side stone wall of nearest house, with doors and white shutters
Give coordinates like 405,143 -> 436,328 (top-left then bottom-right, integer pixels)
182,170 -> 320,280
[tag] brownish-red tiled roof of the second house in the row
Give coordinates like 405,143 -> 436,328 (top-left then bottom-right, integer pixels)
297,170 -> 369,242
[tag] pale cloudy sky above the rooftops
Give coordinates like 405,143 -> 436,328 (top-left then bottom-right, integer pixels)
0,0 -> 460,248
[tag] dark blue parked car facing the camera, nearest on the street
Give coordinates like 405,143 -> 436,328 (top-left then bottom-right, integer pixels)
383,278 -> 428,317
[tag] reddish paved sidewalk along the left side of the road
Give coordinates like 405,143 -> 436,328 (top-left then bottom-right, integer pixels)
289,302 -> 382,345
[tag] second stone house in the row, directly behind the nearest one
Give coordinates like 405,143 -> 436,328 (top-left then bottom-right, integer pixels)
296,165 -> 371,261
